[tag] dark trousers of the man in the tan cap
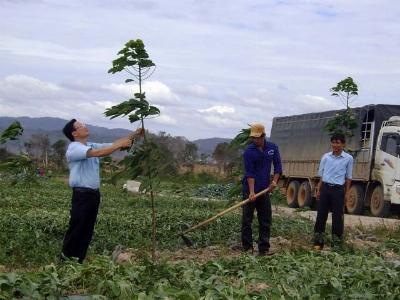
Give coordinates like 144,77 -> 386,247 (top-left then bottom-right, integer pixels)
242,194 -> 272,252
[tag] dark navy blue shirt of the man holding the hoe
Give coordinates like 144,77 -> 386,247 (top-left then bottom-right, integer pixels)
242,141 -> 282,194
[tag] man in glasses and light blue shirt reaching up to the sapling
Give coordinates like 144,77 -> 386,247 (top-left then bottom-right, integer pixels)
61,119 -> 143,263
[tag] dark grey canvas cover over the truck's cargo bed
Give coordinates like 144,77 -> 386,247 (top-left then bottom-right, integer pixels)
271,104 -> 400,180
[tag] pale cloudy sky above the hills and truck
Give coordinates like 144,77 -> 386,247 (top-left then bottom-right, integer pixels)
0,0 -> 400,140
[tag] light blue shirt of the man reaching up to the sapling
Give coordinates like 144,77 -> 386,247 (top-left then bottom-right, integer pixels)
65,142 -> 112,189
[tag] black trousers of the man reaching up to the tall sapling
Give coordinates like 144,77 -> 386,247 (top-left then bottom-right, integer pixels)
63,188 -> 100,262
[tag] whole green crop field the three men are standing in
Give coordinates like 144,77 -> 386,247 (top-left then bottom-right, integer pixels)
0,179 -> 400,299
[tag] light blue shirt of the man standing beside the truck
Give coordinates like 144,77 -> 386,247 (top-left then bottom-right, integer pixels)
318,151 -> 353,185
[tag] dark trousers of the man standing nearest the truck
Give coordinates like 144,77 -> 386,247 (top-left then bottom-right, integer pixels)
314,183 -> 345,246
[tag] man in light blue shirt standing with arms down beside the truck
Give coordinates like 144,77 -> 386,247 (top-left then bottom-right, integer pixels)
314,133 -> 353,250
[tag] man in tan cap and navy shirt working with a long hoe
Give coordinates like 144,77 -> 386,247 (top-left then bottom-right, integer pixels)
242,123 -> 282,256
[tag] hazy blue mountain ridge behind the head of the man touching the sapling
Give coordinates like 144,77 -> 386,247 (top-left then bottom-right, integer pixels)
0,117 -> 131,152
